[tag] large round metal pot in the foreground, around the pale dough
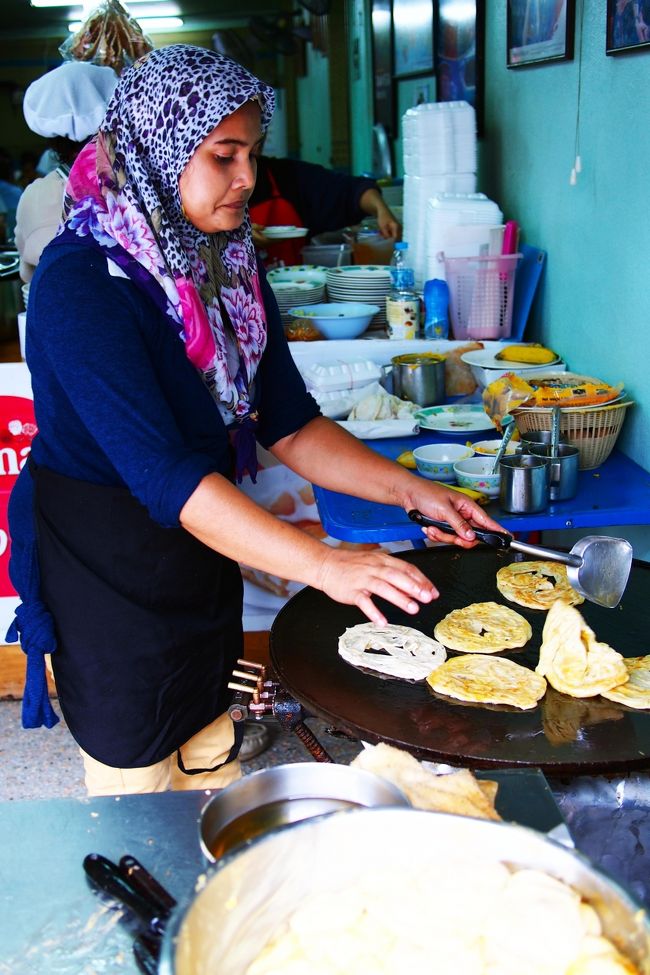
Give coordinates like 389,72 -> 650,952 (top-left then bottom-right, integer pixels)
159,809 -> 650,975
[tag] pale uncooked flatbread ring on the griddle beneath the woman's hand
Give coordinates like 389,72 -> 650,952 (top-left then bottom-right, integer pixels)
339,623 -> 447,680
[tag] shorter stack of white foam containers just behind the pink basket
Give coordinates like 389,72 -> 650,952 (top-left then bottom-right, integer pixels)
423,193 -> 503,281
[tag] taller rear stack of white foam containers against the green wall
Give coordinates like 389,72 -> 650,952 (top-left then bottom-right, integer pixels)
402,102 -> 477,288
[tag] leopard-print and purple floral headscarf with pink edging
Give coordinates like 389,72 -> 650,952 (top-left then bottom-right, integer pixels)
61,44 -> 274,423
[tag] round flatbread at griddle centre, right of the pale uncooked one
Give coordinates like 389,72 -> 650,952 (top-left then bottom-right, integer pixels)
433,603 -> 533,653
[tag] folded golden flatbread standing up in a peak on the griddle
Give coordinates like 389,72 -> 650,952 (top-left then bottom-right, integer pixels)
535,602 -> 629,697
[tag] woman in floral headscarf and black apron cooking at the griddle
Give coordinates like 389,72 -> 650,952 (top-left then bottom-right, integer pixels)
10,45 -> 497,795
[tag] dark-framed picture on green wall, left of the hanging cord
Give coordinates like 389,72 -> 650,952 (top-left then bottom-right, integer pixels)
506,0 -> 575,68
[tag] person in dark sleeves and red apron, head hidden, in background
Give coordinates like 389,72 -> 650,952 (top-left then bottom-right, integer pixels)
248,156 -> 402,268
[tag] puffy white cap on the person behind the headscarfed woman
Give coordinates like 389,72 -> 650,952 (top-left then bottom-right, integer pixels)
23,61 -> 118,142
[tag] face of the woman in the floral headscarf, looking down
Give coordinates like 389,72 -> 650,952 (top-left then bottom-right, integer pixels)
178,102 -> 263,234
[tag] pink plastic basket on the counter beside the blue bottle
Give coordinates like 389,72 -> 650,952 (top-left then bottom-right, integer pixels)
441,254 -> 521,339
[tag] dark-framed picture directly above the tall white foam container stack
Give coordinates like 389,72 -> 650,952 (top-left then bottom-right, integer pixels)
436,0 -> 485,132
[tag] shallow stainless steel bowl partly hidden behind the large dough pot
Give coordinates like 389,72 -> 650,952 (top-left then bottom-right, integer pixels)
199,762 -> 410,861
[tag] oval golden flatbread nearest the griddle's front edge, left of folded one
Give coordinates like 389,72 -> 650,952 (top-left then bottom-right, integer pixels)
427,654 -> 546,711
